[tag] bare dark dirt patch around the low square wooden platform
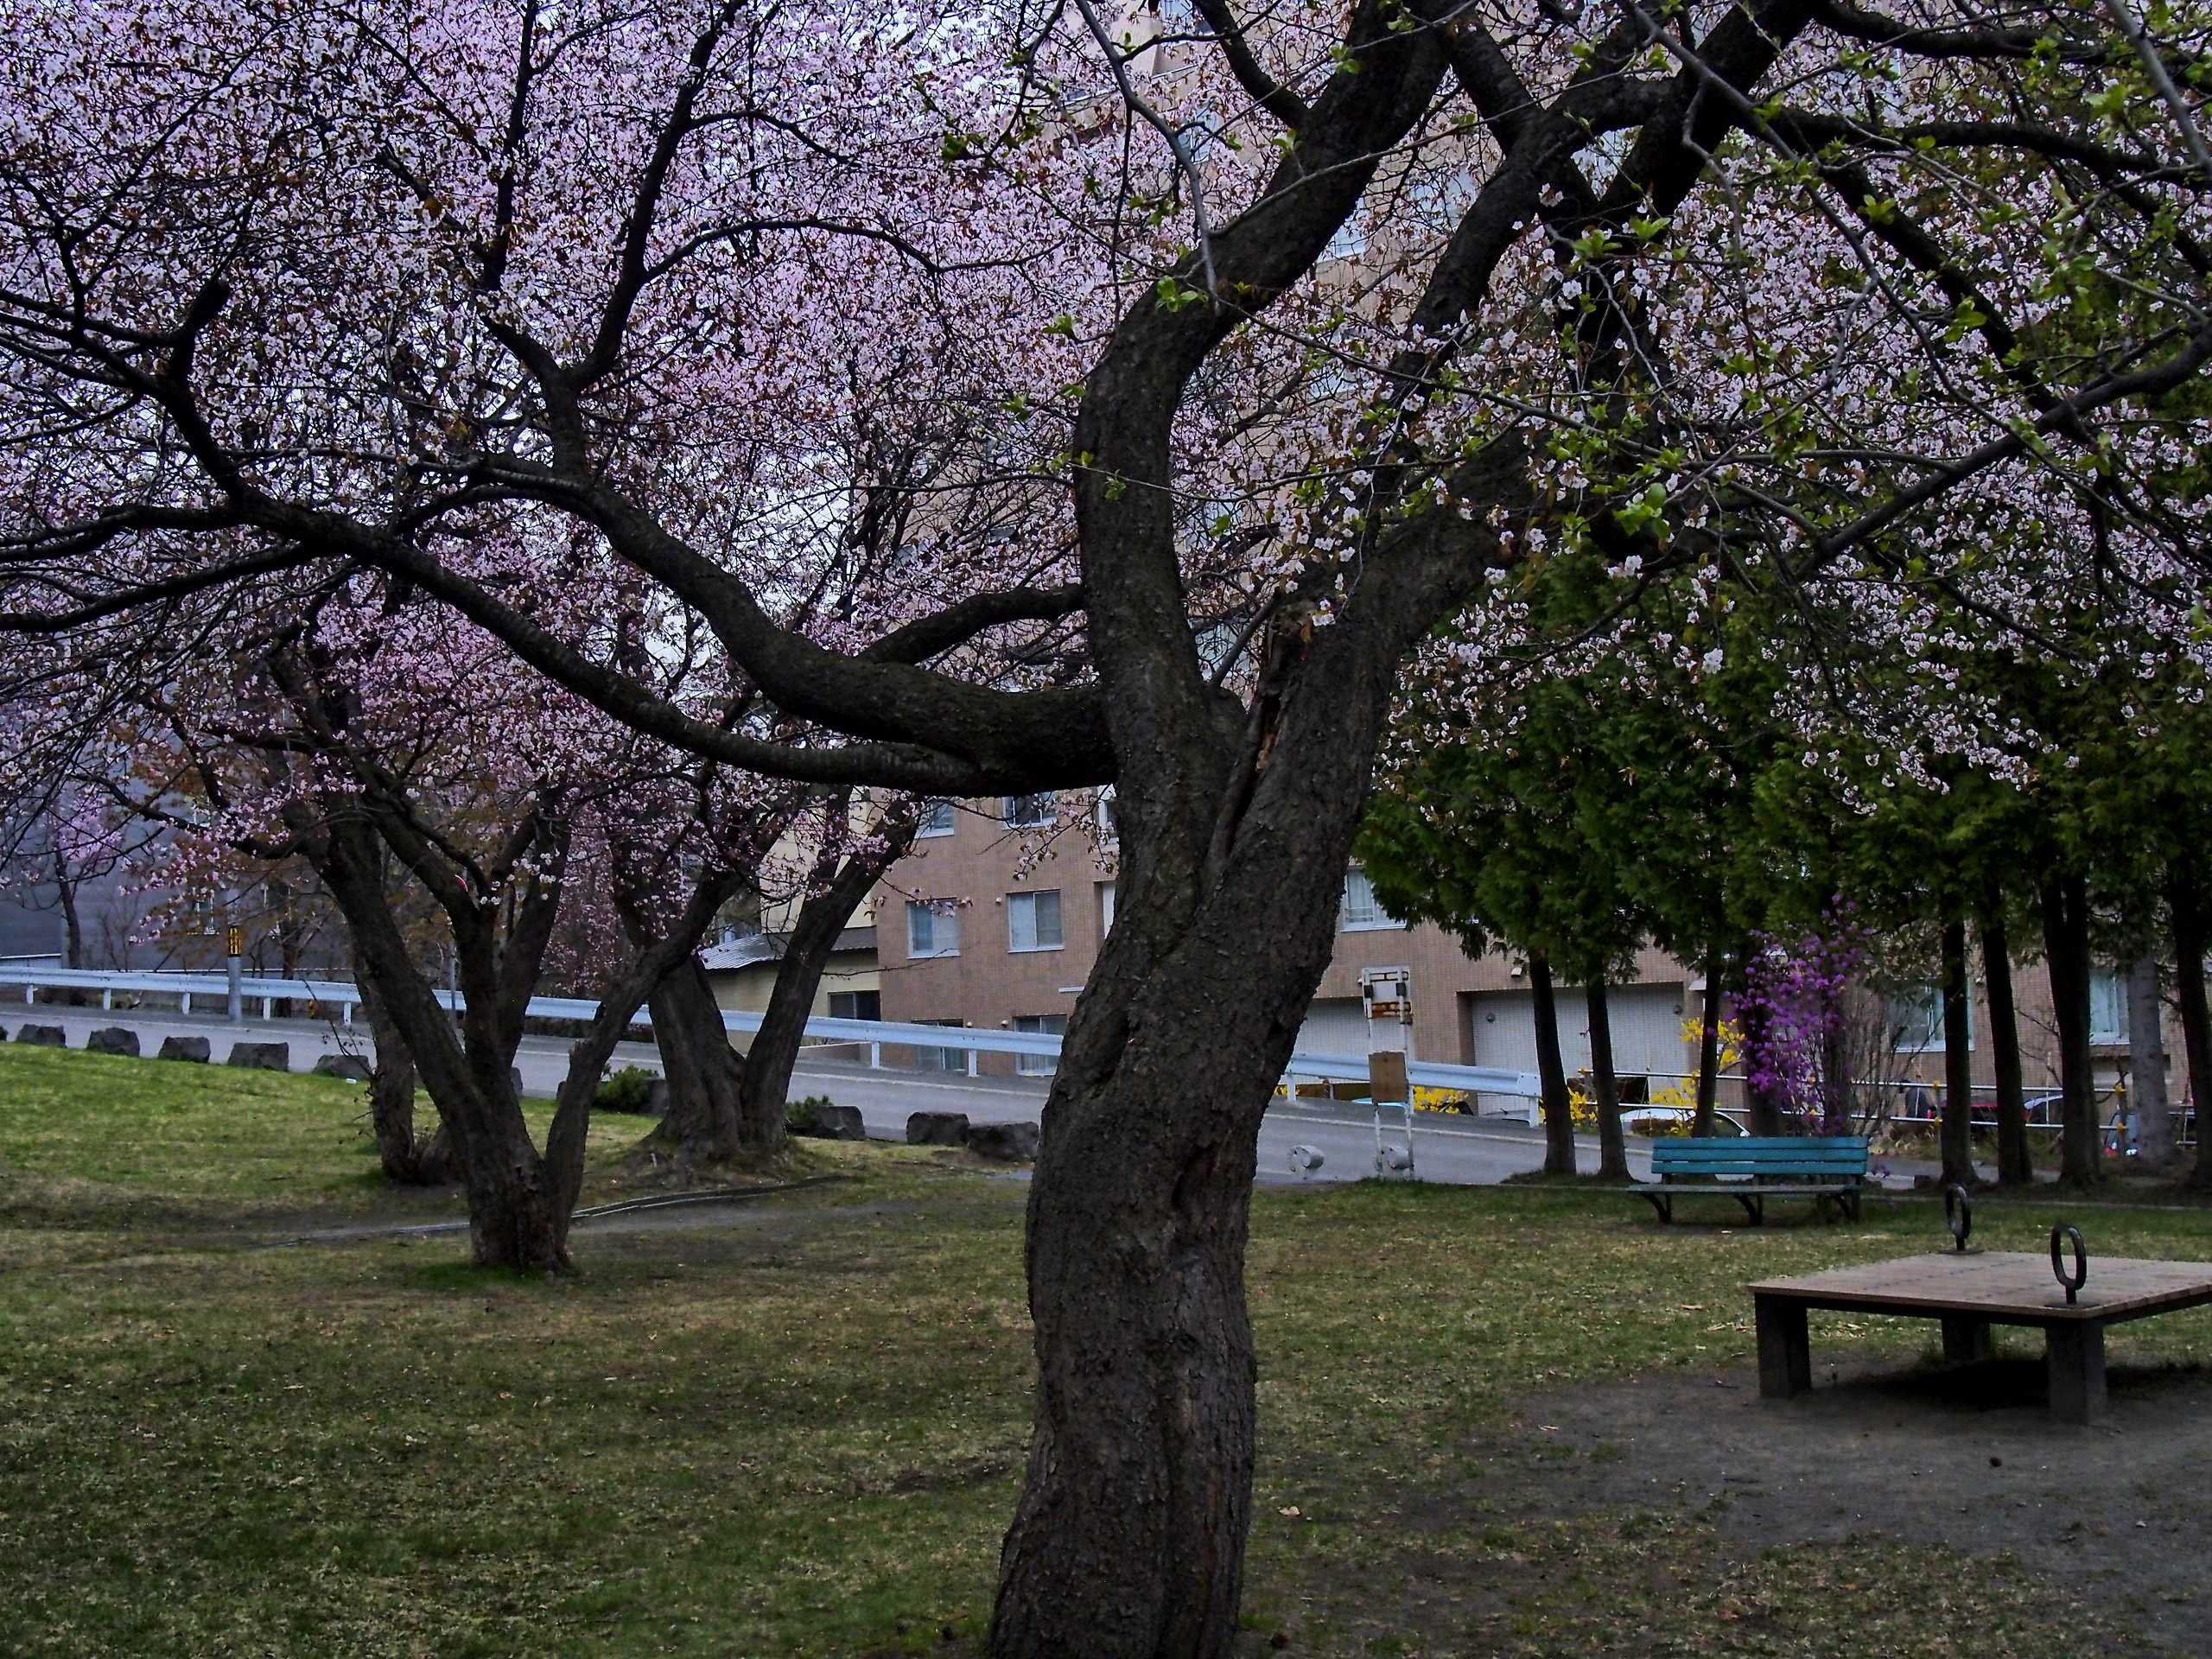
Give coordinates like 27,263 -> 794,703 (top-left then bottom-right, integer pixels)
1400,1332 -> 2212,1655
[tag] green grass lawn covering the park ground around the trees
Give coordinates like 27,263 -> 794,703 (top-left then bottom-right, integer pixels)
0,1048 -> 2212,1659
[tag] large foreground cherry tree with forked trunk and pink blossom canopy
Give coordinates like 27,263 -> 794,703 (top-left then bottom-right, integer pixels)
0,0 -> 2212,1659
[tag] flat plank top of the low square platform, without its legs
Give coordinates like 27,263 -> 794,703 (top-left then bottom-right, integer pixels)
1750,1249 -> 2212,1323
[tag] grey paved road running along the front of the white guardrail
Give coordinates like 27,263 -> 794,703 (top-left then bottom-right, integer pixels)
0,1002 -> 1929,1185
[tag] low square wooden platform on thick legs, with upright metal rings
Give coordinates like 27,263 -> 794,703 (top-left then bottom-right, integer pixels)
1750,1252 -> 2212,1422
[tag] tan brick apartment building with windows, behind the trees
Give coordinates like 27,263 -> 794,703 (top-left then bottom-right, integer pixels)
872,797 -> 2188,1132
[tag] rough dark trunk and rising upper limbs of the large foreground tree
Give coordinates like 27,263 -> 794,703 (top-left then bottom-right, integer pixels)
991,0 -> 1805,1659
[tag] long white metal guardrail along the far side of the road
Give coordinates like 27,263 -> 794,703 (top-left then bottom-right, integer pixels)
0,963 -> 1537,1096
